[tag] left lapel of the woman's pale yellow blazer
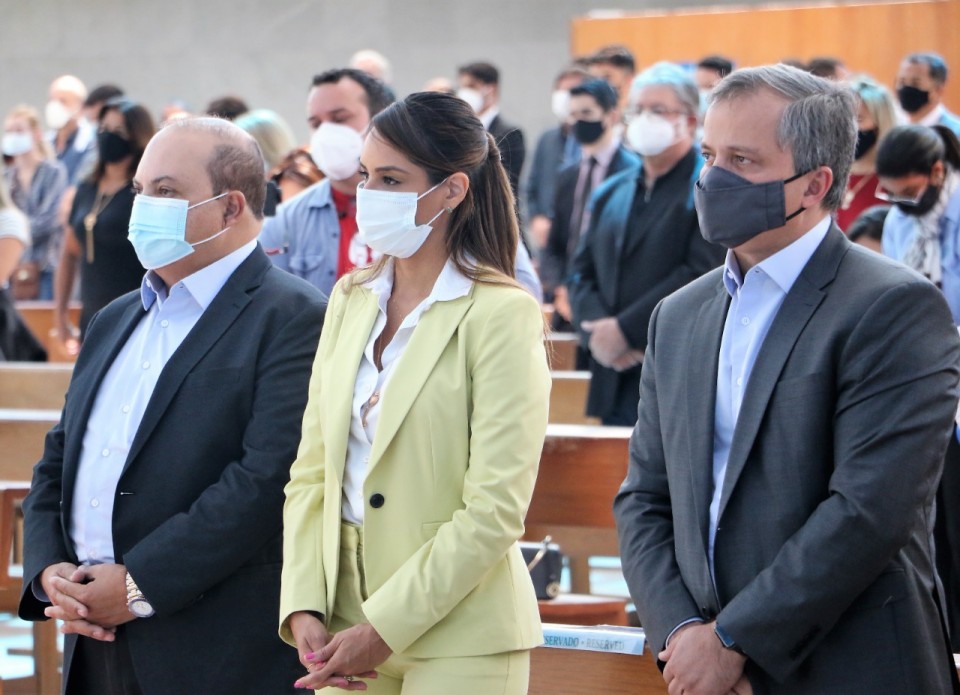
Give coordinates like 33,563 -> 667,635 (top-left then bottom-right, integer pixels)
320,287 -> 382,485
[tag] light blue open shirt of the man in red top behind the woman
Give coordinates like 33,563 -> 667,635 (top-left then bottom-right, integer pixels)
260,179 -> 543,302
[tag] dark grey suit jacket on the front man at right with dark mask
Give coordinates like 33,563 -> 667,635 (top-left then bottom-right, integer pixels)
614,227 -> 960,695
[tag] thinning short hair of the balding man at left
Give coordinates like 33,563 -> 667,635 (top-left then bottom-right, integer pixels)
164,117 -> 267,220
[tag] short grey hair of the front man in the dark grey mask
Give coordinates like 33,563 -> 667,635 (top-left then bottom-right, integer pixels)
709,64 -> 857,211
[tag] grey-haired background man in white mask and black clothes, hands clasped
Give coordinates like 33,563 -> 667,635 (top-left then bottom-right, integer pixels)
568,63 -> 723,425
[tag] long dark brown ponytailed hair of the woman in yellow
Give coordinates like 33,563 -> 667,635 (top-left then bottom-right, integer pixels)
350,92 -> 520,285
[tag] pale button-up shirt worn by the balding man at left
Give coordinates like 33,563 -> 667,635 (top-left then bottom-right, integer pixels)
70,241 -> 257,564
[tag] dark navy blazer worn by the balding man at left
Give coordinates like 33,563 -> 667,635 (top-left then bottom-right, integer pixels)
20,246 -> 326,695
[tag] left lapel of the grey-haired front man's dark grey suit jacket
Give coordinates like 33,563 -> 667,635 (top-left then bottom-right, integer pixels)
686,276 -> 730,557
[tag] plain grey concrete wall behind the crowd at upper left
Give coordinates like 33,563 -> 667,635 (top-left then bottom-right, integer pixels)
0,0 -> 852,158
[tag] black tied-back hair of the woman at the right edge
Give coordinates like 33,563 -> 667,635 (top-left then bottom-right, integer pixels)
877,124 -> 960,179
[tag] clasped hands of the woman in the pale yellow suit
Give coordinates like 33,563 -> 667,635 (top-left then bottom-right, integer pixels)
290,612 -> 393,690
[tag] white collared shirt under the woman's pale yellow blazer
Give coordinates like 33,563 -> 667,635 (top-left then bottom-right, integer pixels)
341,259 -> 473,525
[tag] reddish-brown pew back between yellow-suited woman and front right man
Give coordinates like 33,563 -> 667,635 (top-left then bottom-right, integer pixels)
524,424 -> 632,594
